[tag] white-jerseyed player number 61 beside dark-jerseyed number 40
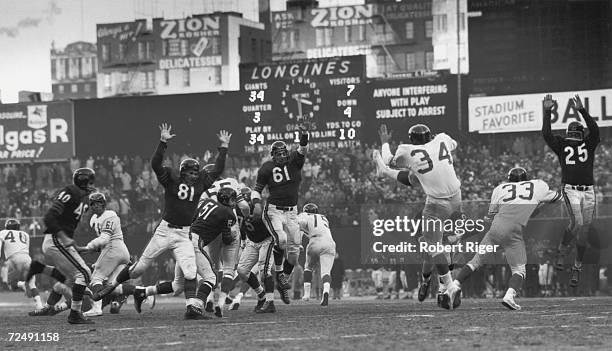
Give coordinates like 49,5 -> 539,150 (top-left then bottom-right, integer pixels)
75,192 -> 134,317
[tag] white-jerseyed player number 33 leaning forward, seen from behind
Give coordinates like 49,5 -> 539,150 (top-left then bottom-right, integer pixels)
455,167 -> 562,310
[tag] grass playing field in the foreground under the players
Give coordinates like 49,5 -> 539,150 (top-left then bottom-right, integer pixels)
0,294 -> 612,351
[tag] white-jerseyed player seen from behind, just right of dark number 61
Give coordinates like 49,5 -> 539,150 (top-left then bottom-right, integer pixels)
298,203 -> 336,306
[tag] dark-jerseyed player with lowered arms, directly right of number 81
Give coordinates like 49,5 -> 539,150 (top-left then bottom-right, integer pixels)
186,188 -> 238,319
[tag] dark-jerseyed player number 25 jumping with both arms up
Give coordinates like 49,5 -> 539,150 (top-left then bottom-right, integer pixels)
542,94 -> 600,287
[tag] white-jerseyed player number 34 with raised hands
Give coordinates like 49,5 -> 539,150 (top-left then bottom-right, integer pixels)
373,124 -> 461,309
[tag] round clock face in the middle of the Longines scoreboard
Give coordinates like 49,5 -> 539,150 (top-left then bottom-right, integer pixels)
280,77 -> 321,121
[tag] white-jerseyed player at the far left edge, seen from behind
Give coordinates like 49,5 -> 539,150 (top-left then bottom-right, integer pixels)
0,219 -> 42,309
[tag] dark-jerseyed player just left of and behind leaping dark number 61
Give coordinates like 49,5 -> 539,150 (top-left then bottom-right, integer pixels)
233,191 -> 276,313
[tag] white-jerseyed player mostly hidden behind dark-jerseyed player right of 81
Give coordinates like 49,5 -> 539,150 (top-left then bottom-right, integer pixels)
200,168 -> 251,317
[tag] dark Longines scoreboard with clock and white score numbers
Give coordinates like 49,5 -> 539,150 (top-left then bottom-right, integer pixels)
240,56 -> 365,152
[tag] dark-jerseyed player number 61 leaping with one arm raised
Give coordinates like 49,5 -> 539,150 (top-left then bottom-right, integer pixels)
252,123 -> 308,304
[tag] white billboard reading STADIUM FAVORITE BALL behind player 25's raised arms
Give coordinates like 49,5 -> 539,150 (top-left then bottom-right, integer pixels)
468,89 -> 612,133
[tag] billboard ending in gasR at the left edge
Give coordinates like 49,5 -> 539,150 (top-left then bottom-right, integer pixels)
0,102 -> 74,163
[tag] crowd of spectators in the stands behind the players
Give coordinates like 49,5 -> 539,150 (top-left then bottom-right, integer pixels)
0,134 -> 612,233
